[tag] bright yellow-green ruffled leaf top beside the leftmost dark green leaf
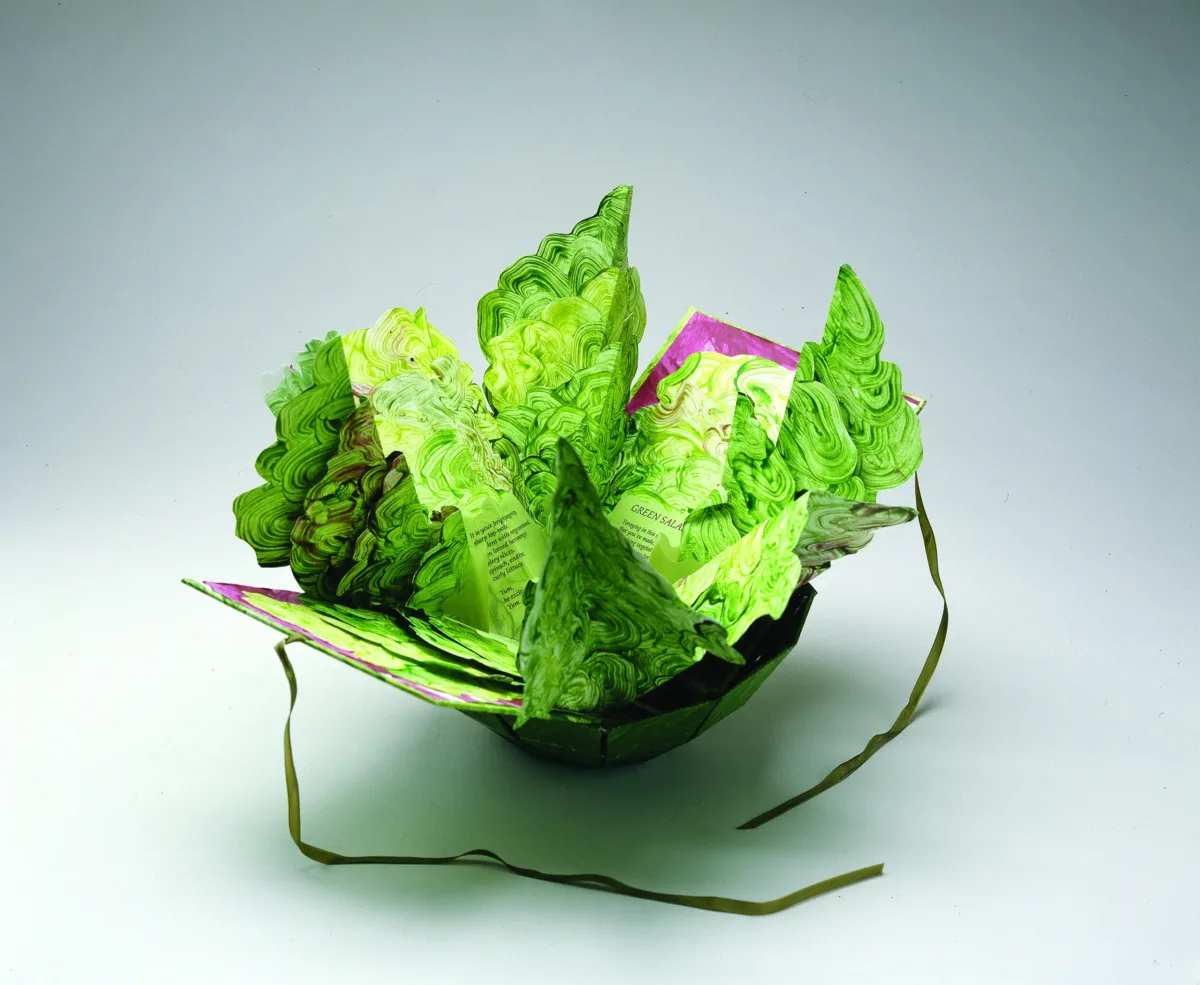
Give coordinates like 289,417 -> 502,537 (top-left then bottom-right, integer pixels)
342,308 -> 458,396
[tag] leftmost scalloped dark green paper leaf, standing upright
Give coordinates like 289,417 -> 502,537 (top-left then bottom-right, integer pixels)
233,335 -> 354,567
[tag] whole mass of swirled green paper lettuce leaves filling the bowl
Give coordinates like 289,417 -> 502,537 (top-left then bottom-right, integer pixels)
223,186 -> 922,723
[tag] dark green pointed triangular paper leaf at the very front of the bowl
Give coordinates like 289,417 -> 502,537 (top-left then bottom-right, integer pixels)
517,440 -> 743,727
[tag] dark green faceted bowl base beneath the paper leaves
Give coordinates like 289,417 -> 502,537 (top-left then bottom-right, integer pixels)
463,584 -> 816,769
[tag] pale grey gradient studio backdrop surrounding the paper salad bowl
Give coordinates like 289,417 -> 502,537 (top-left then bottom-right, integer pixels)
0,0 -> 1200,985
